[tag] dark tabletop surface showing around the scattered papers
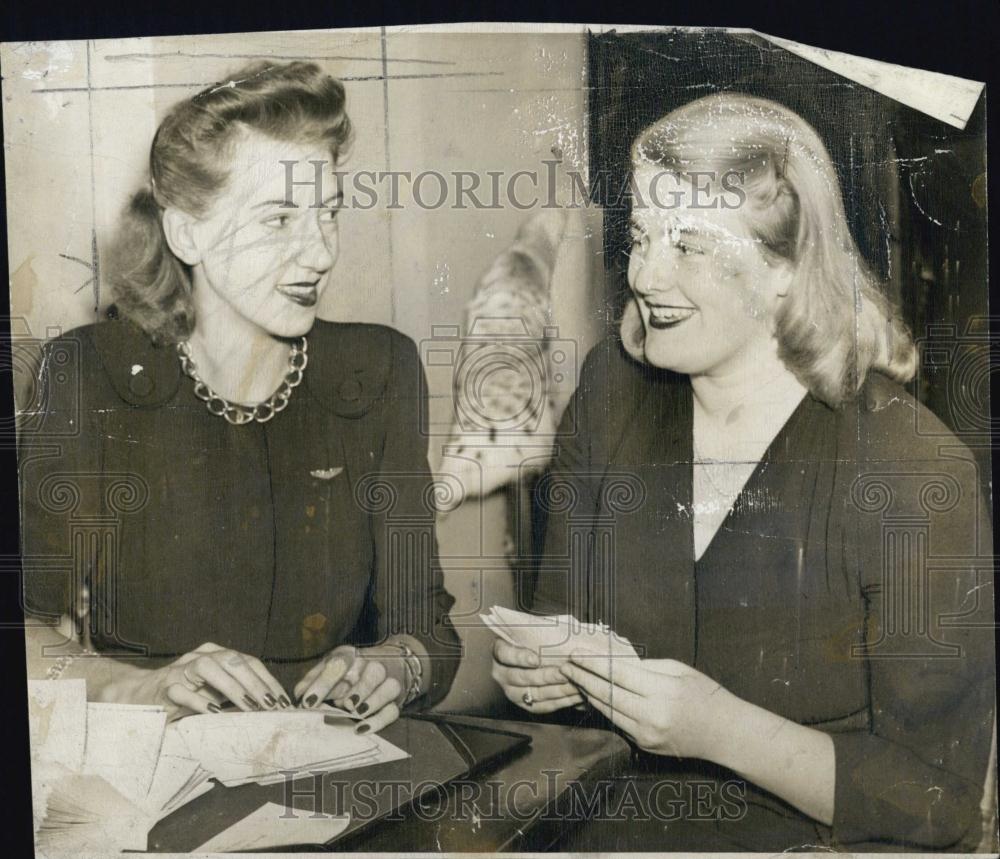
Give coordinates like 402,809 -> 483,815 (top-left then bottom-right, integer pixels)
148,716 -> 629,852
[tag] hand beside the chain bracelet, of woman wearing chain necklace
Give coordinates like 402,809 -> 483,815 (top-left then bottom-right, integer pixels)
293,645 -> 407,734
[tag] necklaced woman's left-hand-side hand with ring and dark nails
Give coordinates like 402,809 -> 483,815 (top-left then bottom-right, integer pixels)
111,642 -> 291,720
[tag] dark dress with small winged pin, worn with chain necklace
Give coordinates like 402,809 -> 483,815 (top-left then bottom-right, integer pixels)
20,321 -> 459,704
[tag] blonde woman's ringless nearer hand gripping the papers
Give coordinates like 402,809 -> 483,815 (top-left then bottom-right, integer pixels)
561,653 -> 739,760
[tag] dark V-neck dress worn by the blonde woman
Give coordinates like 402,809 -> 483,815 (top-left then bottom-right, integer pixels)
533,341 -> 995,851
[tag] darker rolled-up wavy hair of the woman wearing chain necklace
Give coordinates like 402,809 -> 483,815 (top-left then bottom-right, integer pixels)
109,61 -> 351,342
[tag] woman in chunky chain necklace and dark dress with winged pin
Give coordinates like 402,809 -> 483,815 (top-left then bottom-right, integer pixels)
21,62 -> 459,732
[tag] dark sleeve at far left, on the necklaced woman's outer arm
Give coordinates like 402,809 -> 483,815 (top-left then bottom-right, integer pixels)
18,331 -> 96,619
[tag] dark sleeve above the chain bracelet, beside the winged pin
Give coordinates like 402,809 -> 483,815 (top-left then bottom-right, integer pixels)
361,332 -> 462,707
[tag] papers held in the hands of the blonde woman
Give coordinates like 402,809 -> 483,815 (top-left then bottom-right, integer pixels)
479,606 -> 639,665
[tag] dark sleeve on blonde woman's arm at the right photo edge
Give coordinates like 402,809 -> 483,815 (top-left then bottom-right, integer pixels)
832,434 -> 995,852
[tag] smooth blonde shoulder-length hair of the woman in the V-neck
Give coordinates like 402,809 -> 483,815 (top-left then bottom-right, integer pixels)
621,93 -> 916,407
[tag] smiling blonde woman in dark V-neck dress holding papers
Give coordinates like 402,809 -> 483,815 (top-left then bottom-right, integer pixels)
494,93 -> 994,851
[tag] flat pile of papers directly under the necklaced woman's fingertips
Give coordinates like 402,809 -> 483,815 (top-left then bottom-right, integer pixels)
168,710 -> 408,787
